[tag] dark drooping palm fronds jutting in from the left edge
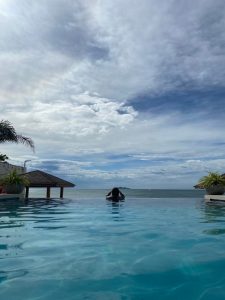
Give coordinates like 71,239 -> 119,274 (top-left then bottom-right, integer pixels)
0,120 -> 34,151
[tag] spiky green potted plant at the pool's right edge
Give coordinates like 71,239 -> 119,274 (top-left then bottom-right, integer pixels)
198,172 -> 225,195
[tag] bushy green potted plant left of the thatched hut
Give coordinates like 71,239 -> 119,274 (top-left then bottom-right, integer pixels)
1,169 -> 29,194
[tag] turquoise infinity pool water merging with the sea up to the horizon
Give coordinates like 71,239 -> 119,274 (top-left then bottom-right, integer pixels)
0,190 -> 225,300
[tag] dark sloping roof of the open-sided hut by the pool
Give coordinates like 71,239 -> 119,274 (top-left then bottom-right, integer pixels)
22,170 -> 75,187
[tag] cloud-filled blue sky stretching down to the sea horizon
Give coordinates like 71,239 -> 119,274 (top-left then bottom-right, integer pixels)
0,0 -> 225,189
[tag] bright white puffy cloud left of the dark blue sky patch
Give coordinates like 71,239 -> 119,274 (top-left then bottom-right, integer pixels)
4,93 -> 137,139
